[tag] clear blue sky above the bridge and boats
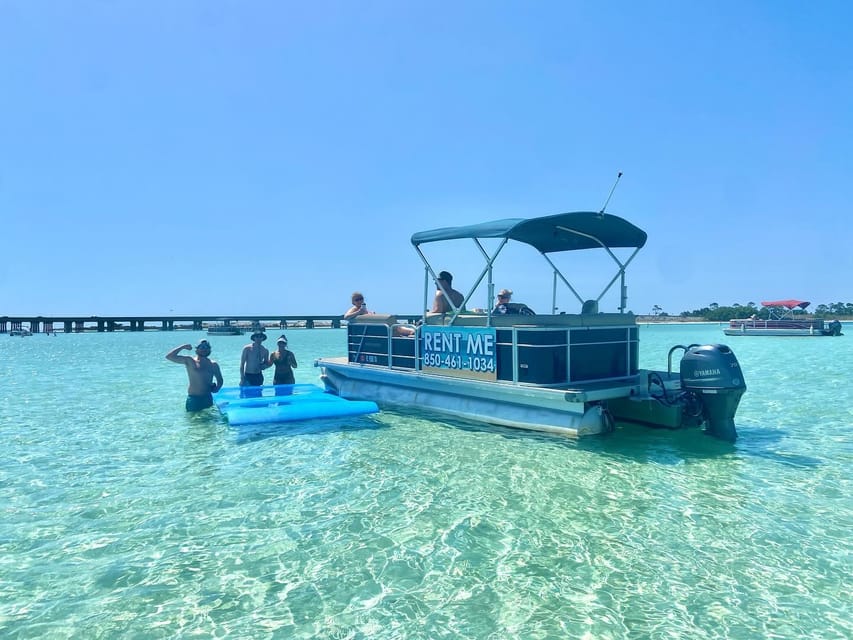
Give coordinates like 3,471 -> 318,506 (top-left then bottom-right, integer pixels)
0,0 -> 853,316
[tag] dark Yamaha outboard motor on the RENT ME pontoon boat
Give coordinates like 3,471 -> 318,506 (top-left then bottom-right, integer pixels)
681,344 -> 746,442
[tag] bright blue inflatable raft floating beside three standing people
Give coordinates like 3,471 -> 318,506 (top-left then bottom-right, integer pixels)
213,384 -> 379,426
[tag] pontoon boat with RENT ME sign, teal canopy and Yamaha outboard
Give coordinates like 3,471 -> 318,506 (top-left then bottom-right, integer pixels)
315,211 -> 746,441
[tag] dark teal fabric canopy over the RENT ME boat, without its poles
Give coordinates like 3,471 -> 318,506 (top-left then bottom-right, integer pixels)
412,211 -> 647,253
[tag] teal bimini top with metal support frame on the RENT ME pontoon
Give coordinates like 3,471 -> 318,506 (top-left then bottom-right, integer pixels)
412,211 -> 647,323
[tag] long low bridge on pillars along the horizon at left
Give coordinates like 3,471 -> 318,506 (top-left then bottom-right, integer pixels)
0,314 -> 421,333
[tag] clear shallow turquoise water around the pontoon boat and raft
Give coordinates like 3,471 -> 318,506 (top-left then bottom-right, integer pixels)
0,324 -> 853,639
